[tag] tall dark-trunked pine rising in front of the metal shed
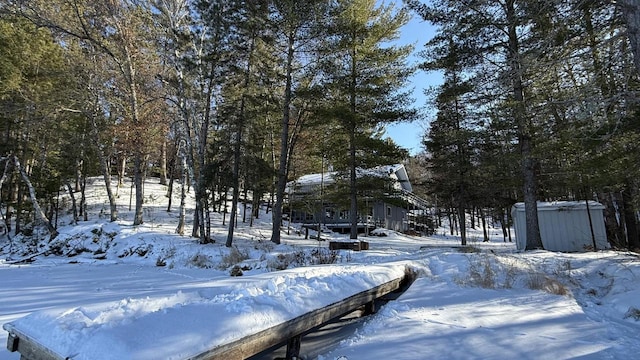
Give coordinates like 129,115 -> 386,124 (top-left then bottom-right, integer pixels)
409,0 -> 545,249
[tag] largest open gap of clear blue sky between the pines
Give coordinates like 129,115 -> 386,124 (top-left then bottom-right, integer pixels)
386,0 -> 442,155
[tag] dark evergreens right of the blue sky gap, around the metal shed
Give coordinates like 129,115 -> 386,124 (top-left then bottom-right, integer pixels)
407,0 -> 640,249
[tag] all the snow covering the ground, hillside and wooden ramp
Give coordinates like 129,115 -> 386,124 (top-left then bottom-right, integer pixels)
0,179 -> 640,360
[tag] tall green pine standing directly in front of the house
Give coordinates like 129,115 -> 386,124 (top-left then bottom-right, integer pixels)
323,0 -> 415,239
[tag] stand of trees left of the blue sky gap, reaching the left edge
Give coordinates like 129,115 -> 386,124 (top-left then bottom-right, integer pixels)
0,0 -> 416,246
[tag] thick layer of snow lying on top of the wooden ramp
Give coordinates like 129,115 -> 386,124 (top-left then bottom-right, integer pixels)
2,265 -> 404,360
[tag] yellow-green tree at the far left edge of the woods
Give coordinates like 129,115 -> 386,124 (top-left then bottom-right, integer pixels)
0,16 -> 74,238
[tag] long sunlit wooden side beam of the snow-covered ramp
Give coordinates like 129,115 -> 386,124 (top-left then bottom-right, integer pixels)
190,277 -> 405,360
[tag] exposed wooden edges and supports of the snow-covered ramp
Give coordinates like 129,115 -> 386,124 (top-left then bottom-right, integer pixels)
4,268 -> 415,360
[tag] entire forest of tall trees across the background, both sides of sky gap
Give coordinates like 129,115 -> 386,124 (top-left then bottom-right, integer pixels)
0,0 -> 640,253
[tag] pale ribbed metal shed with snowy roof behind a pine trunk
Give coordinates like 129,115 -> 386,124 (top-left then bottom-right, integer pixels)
512,201 -> 610,252
